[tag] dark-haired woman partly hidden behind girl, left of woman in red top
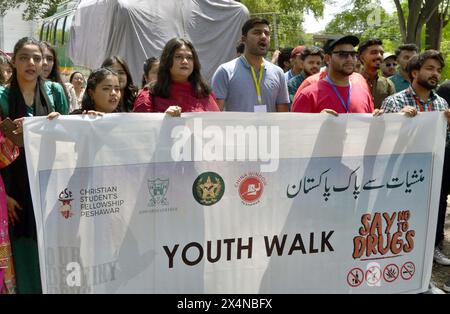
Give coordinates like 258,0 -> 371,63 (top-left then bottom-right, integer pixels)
101,56 -> 138,112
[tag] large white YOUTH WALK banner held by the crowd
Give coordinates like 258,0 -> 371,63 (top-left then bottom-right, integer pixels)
24,112 -> 447,293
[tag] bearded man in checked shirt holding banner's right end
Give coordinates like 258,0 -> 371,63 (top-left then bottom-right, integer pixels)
381,50 -> 450,272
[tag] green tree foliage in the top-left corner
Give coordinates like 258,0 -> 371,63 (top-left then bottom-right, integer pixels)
0,0 -> 66,20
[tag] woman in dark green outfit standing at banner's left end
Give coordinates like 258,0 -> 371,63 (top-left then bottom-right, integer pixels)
0,37 -> 68,293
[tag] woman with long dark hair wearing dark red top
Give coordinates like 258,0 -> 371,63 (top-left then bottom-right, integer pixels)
133,38 -> 220,115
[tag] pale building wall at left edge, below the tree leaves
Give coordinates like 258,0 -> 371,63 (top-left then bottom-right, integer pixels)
0,8 -> 38,52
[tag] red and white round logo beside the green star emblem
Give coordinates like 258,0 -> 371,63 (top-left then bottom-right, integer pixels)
236,173 -> 266,205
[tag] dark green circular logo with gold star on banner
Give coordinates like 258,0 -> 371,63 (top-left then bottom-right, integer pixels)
192,172 -> 225,206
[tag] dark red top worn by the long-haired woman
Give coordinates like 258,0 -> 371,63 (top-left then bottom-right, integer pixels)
133,82 -> 220,112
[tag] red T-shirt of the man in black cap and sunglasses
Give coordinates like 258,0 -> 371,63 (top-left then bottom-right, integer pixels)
291,80 -> 374,113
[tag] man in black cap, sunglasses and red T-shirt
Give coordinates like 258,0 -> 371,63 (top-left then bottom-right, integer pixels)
291,35 -> 374,115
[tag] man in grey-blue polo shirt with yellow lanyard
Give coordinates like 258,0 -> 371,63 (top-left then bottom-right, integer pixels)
212,17 -> 289,112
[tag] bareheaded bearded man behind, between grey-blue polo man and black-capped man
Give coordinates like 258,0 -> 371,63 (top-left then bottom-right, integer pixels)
288,47 -> 323,102
